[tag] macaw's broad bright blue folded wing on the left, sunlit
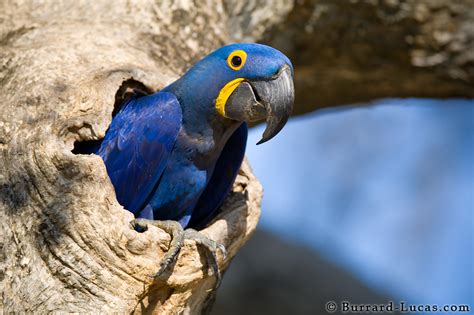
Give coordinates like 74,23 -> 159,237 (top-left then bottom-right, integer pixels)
97,92 -> 182,215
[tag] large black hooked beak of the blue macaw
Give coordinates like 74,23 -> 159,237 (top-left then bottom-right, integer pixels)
225,64 -> 295,144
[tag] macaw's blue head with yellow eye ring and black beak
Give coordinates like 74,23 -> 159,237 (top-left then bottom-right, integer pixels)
166,43 -> 294,144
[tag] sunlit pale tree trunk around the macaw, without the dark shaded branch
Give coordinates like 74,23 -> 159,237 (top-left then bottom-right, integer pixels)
0,1 -> 290,314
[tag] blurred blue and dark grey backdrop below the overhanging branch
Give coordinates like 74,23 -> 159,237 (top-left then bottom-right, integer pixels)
214,99 -> 474,314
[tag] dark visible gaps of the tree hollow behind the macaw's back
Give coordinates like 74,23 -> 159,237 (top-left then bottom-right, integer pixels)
72,79 -> 153,154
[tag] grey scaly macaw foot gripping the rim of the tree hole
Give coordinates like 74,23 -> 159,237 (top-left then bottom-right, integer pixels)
130,218 -> 227,289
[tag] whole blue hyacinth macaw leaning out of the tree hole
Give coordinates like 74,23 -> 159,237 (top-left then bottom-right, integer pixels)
96,43 -> 294,288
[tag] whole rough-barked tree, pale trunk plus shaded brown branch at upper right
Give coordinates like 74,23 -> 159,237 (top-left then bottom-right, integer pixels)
0,0 -> 474,314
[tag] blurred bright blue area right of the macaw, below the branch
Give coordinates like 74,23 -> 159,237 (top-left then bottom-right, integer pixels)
247,99 -> 474,307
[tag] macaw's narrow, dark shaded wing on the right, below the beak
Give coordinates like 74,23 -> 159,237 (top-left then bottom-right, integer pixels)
188,123 -> 248,228
